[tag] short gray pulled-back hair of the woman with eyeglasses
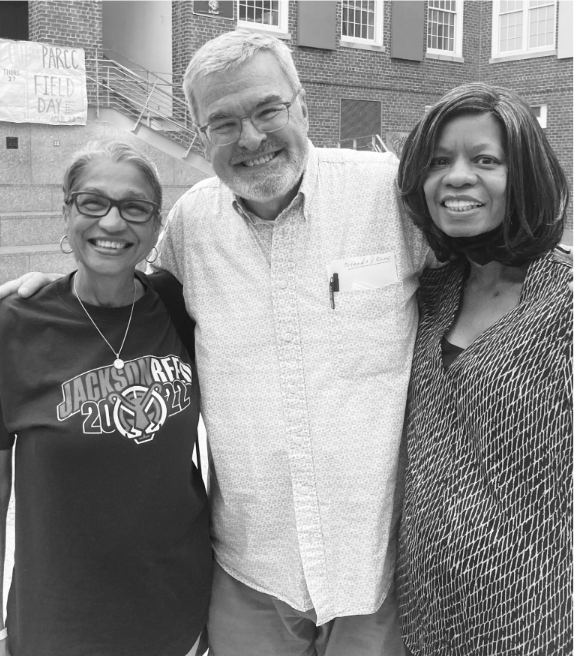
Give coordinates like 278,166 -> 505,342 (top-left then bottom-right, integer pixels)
63,140 -> 163,225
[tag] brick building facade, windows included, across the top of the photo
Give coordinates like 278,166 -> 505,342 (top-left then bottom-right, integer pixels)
2,0 -> 572,230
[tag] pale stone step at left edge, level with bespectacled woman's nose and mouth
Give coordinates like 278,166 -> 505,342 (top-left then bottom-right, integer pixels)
0,212 -> 64,247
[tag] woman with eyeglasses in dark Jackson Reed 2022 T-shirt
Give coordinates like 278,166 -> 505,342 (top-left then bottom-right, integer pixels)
0,142 -> 212,656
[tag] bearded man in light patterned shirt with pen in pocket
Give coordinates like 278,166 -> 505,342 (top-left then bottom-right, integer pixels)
0,31 -> 428,656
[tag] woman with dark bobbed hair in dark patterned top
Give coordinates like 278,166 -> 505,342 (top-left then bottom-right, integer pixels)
397,83 -> 572,656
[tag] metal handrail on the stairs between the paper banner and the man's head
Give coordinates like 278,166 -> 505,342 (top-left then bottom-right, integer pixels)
86,58 -> 204,158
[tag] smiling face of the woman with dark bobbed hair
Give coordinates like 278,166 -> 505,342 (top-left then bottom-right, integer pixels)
423,114 -> 508,237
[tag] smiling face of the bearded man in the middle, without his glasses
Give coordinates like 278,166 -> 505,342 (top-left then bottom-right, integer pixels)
193,52 -> 308,215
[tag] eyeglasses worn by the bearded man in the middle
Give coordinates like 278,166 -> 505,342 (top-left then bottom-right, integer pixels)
199,89 -> 301,146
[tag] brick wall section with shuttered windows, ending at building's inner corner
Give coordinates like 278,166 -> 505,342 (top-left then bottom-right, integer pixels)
172,0 -> 480,140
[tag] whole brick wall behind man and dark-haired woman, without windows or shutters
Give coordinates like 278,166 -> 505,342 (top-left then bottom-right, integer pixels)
173,0 -> 572,236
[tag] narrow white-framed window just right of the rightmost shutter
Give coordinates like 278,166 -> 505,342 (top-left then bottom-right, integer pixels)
427,0 -> 464,57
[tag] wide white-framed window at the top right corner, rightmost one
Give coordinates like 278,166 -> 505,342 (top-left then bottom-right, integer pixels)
492,0 -> 556,57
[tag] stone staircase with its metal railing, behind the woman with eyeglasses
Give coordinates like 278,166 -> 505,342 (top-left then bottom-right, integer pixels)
0,51 -> 213,284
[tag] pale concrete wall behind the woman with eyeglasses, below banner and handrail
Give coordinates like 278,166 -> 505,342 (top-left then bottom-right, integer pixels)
0,117 -> 206,283
